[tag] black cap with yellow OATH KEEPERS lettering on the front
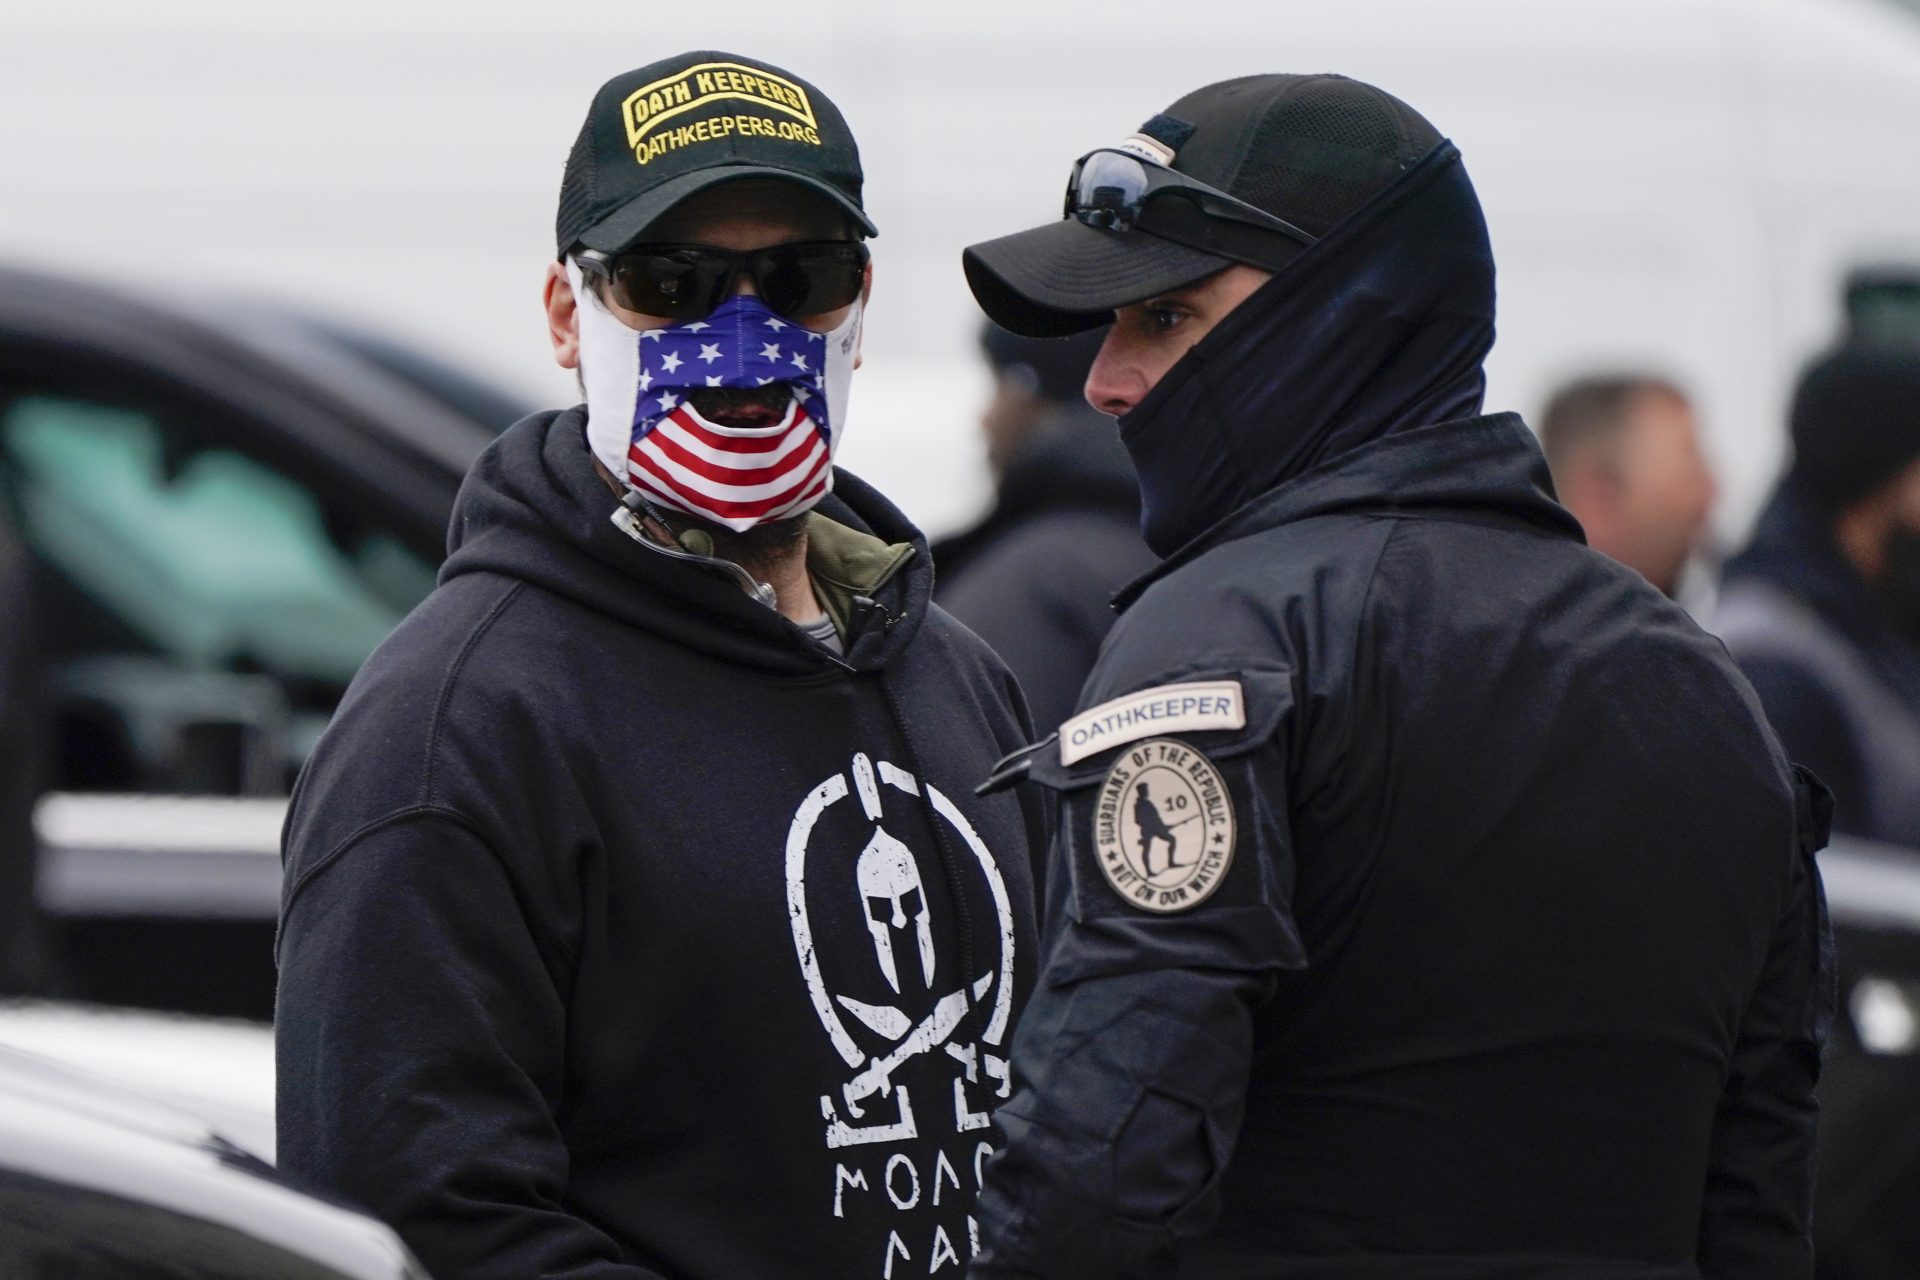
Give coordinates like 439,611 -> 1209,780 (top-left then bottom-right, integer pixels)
555,50 -> 879,257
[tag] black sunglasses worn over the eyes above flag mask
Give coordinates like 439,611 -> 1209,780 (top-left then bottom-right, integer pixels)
574,240 -> 870,320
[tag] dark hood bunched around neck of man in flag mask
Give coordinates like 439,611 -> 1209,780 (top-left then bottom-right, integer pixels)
440,405 -> 933,676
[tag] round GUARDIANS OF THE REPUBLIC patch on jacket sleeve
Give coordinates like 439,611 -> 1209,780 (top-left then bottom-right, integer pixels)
1092,737 -> 1233,912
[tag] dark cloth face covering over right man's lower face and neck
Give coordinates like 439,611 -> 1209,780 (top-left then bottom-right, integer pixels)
1119,142 -> 1494,557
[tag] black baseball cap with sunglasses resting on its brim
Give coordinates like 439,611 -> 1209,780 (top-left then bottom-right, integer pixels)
962,75 -> 1442,336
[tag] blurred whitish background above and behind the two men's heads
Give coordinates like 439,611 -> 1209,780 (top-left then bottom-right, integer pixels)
0,0 -> 1920,528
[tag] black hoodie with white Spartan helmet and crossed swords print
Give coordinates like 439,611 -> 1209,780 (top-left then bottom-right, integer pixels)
278,409 -> 1044,1280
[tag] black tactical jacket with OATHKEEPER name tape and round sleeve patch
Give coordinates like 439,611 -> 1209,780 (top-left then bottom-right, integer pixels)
972,415 -> 1832,1280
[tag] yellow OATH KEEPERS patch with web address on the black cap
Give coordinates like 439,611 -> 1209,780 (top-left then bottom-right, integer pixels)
620,61 -> 820,165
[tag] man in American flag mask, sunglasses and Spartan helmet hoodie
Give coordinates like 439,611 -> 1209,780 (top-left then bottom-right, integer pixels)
276,52 -> 1044,1280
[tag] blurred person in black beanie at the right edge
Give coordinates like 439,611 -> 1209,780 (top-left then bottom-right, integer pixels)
1715,340 -> 1920,848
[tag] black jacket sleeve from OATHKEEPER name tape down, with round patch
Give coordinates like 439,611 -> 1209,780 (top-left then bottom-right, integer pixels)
975,670 -> 1306,1280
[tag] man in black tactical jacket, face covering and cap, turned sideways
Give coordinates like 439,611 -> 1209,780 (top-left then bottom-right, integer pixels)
966,75 -> 1830,1280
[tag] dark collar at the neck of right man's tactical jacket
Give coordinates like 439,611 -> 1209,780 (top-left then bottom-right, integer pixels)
1114,413 -> 1586,608
